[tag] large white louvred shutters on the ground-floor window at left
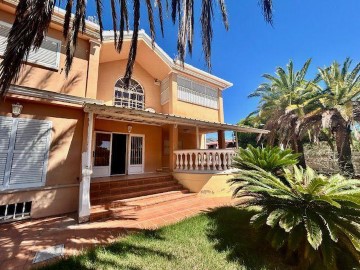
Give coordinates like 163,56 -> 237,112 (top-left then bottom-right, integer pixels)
0,116 -> 52,190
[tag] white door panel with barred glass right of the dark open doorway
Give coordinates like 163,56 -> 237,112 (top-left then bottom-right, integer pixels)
128,135 -> 145,174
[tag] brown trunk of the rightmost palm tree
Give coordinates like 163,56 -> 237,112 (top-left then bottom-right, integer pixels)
334,120 -> 355,177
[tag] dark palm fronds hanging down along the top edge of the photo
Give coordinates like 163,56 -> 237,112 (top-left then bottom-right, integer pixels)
0,0 -> 272,96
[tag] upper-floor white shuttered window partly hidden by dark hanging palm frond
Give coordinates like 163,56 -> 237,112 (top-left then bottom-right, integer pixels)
0,21 -> 61,69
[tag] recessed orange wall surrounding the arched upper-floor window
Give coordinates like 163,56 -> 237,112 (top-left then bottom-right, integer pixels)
97,60 -> 162,113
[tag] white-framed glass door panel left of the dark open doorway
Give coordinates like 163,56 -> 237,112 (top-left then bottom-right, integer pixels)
93,132 -> 111,177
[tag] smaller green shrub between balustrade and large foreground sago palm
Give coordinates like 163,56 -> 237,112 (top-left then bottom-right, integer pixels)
233,145 -> 300,174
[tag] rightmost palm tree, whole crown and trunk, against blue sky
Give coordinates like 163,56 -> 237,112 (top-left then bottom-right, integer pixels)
302,58 -> 360,175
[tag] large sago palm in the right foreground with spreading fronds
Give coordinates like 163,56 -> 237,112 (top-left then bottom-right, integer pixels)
231,166 -> 360,269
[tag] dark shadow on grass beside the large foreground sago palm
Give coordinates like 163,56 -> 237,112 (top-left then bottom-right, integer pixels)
206,207 -> 297,269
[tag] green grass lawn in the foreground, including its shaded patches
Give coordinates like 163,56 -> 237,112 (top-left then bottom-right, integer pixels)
38,207 -> 310,270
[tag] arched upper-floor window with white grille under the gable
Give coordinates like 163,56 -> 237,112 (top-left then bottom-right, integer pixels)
115,78 -> 145,110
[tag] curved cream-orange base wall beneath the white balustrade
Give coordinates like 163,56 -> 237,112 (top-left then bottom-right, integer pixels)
173,173 -> 234,197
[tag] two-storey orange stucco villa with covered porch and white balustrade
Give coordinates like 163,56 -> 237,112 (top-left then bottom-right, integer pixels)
0,0 -> 263,222
